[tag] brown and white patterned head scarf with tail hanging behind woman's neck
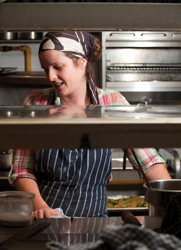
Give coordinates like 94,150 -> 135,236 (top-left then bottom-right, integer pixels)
39,31 -> 99,105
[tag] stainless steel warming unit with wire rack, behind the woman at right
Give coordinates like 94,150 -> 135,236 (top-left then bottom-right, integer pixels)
102,31 -> 181,104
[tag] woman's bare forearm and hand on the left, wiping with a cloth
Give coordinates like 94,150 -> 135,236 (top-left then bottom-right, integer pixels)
15,178 -> 63,218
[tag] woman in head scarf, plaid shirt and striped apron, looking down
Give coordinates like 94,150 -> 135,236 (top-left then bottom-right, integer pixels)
9,31 -> 170,218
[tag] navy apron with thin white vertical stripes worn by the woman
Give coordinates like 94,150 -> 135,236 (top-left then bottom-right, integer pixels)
35,149 -> 111,217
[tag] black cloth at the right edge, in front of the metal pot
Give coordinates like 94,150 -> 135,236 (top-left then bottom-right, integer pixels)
155,194 -> 181,239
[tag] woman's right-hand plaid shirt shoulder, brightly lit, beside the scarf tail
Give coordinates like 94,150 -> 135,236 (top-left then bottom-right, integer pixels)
97,88 -> 129,105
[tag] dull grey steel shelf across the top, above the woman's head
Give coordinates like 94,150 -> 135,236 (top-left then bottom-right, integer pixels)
0,2 -> 181,31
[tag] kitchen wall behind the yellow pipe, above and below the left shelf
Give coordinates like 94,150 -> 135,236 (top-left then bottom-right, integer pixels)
0,43 -> 48,105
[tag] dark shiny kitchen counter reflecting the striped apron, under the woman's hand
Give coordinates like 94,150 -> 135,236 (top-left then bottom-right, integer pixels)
0,216 -> 162,250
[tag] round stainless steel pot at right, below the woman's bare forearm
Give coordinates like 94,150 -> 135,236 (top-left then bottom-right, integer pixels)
143,179 -> 181,216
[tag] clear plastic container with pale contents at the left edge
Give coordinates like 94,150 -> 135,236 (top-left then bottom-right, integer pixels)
0,191 -> 35,227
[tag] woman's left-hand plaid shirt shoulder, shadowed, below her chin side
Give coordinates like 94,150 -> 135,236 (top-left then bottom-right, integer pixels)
23,88 -> 55,105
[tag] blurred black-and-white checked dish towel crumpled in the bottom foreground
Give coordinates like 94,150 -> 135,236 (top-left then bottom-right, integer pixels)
46,224 -> 181,250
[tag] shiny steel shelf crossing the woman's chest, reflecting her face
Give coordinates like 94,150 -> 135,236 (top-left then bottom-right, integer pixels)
0,105 -> 181,149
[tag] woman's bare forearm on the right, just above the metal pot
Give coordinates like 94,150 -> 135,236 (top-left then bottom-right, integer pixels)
145,163 -> 171,181
